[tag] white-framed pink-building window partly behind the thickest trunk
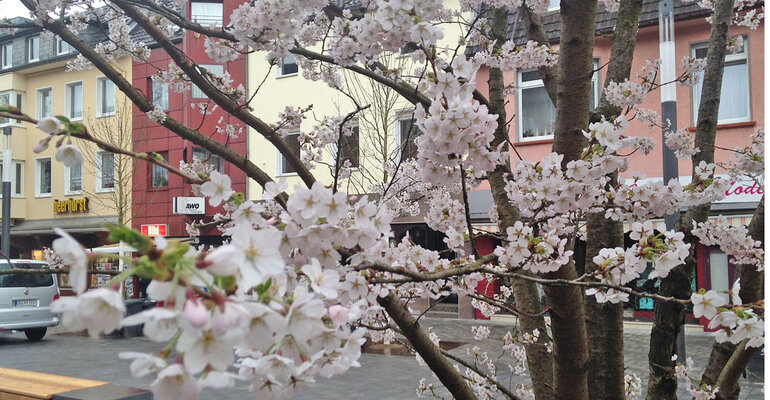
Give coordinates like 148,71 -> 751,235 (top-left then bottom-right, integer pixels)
517,60 -> 601,141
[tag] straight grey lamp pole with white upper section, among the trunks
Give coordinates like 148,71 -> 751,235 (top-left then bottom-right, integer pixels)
658,0 -> 687,361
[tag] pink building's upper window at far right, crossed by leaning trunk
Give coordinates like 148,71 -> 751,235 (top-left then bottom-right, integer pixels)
692,38 -> 751,125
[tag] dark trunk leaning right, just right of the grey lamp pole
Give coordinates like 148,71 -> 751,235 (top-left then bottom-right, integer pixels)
647,0 -> 735,400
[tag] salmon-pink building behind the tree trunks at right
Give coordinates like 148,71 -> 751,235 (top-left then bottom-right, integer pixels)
471,0 -> 765,324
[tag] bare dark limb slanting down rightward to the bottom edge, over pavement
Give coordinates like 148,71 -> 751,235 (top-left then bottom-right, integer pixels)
377,292 -> 476,400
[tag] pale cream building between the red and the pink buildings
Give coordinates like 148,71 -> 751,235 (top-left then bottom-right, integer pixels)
247,0 -> 464,199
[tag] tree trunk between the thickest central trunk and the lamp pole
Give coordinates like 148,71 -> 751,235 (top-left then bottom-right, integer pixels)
585,0 -> 642,400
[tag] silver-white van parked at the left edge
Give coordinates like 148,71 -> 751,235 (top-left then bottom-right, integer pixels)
0,259 -> 59,342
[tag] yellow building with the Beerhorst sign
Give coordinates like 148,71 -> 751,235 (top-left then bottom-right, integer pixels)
0,19 -> 132,259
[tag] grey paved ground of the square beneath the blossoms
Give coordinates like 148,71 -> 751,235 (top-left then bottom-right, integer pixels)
0,318 -> 764,400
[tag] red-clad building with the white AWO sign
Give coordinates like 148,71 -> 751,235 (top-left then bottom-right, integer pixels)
132,0 -> 247,243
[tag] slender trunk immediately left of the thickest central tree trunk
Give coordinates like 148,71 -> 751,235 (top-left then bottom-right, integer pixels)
488,8 -> 555,400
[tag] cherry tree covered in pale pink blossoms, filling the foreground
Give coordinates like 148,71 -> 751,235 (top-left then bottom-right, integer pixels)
0,0 -> 764,399
